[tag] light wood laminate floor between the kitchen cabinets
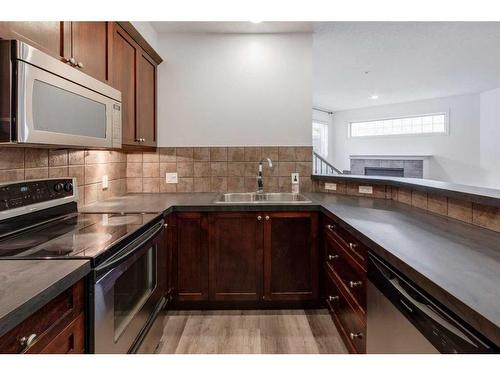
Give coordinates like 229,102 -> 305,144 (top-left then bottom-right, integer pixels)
157,310 -> 347,354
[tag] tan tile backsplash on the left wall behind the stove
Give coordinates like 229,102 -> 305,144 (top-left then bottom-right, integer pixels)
0,147 -> 127,204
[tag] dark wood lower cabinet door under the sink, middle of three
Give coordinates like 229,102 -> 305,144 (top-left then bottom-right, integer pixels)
209,213 -> 263,301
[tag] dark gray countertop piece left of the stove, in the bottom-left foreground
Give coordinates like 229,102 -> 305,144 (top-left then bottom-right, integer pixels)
0,259 -> 90,336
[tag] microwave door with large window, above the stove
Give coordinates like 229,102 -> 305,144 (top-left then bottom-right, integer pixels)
17,61 -> 115,148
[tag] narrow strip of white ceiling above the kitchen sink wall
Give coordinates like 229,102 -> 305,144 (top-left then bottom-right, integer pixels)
151,21 -> 313,34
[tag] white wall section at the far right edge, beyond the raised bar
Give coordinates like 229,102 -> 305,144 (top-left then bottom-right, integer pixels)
480,88 -> 500,189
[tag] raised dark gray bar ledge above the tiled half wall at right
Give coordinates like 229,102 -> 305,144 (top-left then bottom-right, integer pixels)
312,174 -> 500,207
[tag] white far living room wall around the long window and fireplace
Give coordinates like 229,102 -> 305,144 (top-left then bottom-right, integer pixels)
329,94 -> 480,185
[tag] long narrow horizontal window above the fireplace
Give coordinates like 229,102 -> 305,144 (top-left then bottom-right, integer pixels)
349,113 -> 448,137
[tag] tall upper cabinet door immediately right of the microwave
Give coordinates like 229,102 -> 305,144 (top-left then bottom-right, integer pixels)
109,23 -> 139,145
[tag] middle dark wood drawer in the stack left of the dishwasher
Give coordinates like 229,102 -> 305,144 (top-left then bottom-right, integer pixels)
324,235 -> 366,313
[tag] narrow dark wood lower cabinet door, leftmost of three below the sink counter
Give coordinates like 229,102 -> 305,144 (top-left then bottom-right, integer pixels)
175,212 -> 208,301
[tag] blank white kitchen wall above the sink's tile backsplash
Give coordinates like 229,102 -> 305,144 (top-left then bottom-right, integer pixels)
158,33 -> 312,146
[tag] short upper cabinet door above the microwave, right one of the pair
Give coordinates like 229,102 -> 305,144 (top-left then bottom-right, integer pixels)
69,22 -> 108,81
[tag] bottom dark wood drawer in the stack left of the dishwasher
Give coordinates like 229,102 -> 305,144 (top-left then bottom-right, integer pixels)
325,269 -> 366,353
